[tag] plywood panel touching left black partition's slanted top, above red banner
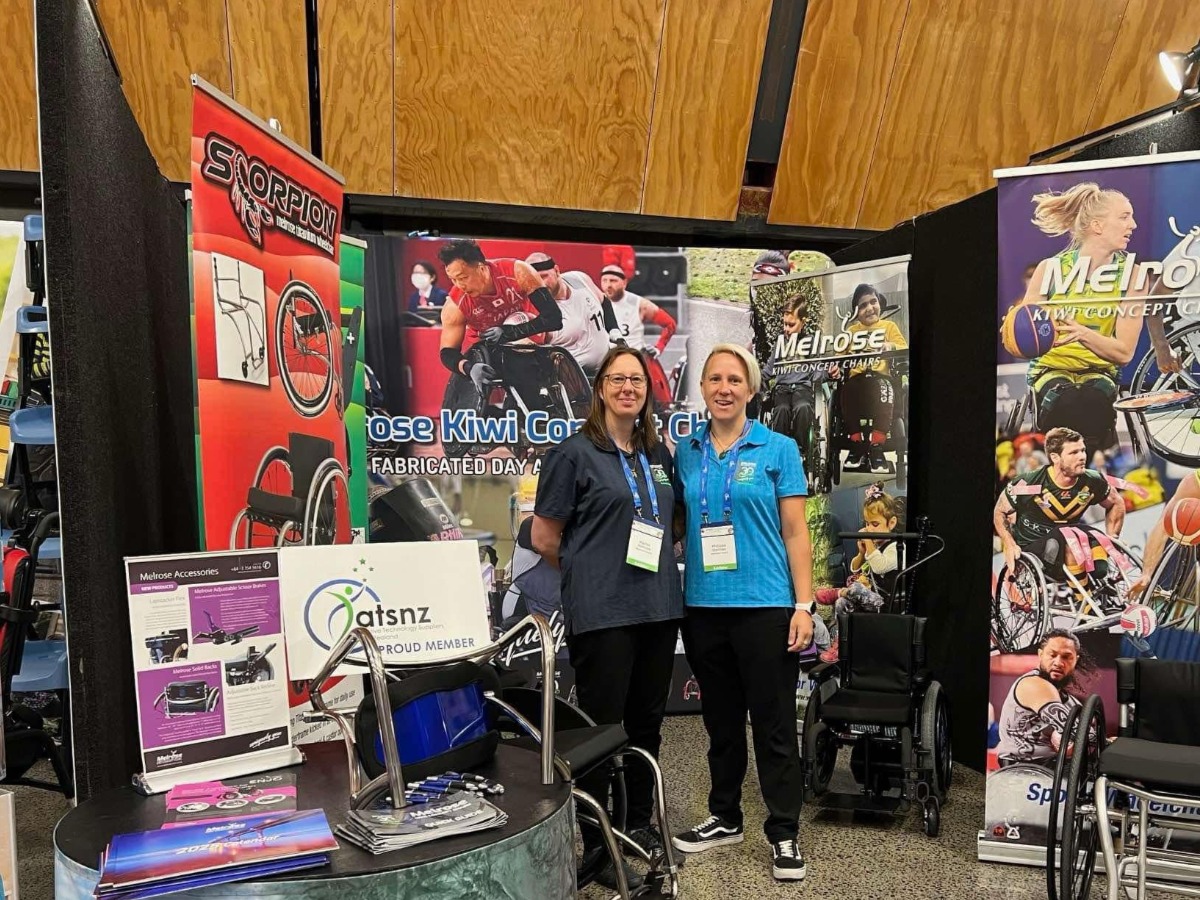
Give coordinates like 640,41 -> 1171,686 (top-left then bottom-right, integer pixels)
96,0 -> 230,181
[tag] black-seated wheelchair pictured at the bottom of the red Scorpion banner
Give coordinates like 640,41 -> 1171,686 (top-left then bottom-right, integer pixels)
229,433 -> 349,550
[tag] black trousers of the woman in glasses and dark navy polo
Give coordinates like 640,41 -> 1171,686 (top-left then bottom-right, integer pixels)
566,620 -> 679,847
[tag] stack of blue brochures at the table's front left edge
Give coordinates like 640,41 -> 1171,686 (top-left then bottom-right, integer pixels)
95,809 -> 337,900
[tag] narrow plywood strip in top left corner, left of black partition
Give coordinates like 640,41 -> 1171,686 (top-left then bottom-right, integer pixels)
0,0 -> 38,172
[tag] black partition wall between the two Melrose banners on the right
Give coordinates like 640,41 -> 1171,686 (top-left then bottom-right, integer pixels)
834,191 -> 996,769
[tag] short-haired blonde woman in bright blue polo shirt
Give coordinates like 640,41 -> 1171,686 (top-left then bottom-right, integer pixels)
673,343 -> 812,881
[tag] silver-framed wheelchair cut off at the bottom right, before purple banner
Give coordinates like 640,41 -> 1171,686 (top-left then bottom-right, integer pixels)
1045,659 -> 1200,900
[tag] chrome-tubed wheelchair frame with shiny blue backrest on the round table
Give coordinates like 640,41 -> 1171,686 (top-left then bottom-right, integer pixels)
306,614 -> 679,900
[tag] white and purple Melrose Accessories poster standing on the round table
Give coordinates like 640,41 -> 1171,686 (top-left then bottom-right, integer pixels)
125,550 -> 300,792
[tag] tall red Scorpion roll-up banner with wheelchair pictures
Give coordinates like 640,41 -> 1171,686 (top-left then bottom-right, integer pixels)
191,79 -> 352,550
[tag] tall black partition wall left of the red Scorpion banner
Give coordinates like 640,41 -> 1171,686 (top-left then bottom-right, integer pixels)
36,0 -> 198,800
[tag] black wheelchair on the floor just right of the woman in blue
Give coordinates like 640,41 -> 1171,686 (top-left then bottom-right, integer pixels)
800,528 -> 954,838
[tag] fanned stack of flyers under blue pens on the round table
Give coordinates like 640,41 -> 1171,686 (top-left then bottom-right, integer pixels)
337,792 -> 509,853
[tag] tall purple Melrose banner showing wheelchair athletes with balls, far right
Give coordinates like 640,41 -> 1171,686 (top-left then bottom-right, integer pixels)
979,154 -> 1200,865
